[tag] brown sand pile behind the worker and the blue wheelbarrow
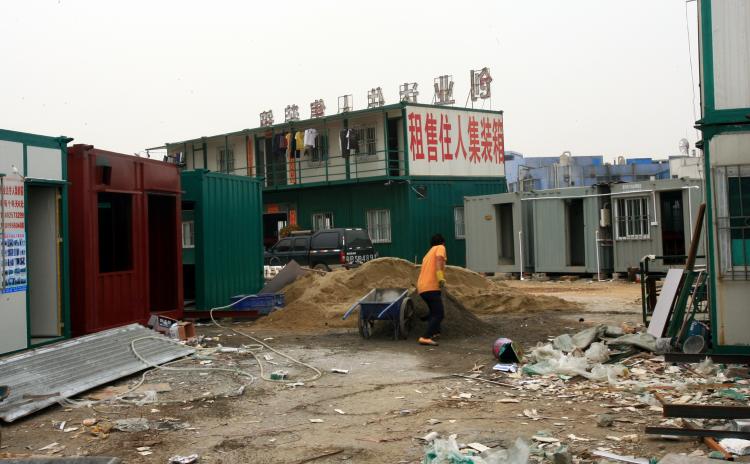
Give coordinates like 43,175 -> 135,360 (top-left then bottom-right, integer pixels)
257,258 -> 577,334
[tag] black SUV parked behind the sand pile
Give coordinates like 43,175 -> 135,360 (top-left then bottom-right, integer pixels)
264,228 -> 378,271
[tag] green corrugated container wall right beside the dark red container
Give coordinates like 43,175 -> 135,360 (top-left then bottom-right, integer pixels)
182,170 -> 263,310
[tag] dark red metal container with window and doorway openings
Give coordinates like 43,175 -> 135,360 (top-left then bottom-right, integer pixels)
68,144 -> 183,336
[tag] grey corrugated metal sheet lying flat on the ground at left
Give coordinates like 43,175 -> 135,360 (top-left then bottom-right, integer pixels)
0,324 -> 195,422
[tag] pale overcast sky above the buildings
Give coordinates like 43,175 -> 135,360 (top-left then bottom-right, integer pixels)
0,0 -> 699,158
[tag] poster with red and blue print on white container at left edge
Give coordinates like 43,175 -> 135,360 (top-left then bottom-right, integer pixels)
0,179 -> 26,293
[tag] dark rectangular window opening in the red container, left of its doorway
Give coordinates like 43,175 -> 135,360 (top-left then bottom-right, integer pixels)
97,193 -> 133,273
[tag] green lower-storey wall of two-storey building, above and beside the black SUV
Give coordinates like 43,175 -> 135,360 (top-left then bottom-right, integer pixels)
264,178 -> 507,266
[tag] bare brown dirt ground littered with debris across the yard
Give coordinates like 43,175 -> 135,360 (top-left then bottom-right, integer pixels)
0,281 -> 740,464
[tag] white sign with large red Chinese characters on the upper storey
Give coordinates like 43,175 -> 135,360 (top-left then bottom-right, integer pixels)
407,108 -> 505,176
